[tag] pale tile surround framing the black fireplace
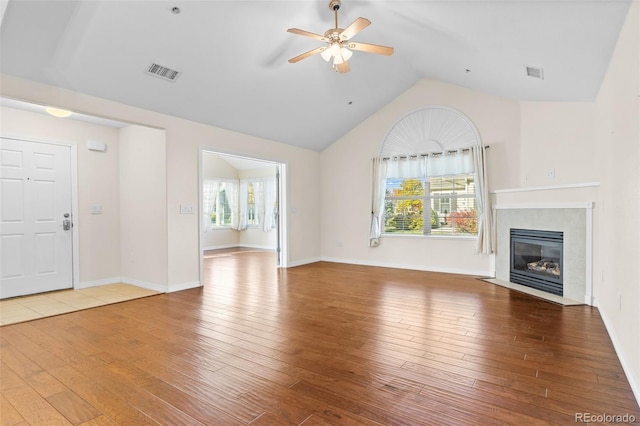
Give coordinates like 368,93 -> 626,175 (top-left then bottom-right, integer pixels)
494,202 -> 593,305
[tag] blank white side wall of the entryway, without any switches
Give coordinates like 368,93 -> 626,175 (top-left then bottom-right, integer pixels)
119,126 -> 167,290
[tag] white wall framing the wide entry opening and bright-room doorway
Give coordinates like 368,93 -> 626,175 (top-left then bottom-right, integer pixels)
0,75 -> 320,290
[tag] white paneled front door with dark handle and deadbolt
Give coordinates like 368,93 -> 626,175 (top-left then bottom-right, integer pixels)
0,138 -> 73,299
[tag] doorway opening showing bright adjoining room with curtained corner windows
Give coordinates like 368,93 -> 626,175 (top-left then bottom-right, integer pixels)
198,147 -> 288,285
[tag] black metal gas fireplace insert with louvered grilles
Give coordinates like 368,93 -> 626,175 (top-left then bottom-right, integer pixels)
509,228 -> 563,296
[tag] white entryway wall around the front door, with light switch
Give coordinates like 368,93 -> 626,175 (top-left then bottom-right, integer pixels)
0,107 -> 120,286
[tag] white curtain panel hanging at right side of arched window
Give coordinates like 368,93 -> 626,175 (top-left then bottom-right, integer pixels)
471,146 -> 494,254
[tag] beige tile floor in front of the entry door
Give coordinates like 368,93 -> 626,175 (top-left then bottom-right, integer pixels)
0,284 -> 160,326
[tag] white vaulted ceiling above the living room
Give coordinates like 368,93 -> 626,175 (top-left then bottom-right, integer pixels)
0,0 -> 631,151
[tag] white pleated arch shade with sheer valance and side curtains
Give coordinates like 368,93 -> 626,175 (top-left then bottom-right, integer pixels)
369,106 -> 493,253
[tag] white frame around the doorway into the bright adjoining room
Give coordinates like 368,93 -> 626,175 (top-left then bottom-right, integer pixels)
196,145 -> 289,287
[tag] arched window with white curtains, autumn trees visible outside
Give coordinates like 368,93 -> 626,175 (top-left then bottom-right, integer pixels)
370,106 -> 491,252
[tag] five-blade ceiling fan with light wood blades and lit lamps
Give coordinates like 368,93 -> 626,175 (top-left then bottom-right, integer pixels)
287,0 -> 393,73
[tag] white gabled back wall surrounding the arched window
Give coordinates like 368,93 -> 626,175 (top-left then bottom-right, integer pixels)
321,79 -> 520,275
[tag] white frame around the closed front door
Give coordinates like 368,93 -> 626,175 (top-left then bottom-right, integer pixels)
0,134 -> 80,290
